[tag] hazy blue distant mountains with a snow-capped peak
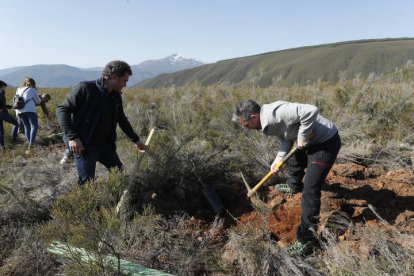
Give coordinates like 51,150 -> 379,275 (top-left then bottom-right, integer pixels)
0,54 -> 205,88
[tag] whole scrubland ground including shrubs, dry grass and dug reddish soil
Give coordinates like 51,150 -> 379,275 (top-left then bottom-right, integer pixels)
0,68 -> 414,275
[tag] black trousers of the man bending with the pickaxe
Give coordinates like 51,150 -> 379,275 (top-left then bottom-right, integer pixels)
288,133 -> 341,243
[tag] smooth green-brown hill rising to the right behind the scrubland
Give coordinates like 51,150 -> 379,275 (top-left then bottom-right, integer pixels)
135,38 -> 414,89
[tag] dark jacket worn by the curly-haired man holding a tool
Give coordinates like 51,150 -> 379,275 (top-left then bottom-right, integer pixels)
56,78 -> 139,149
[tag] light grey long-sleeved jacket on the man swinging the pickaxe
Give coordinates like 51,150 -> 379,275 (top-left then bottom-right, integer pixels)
260,101 -> 338,156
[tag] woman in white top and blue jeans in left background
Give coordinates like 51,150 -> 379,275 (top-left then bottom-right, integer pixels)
16,77 -> 41,149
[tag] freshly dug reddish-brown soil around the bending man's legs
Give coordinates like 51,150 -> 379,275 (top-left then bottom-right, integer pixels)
225,163 -> 414,246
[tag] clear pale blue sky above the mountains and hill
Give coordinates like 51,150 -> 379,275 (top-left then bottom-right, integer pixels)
0,0 -> 414,69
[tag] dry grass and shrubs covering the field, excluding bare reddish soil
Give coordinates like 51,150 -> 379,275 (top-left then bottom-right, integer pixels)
0,69 -> 414,275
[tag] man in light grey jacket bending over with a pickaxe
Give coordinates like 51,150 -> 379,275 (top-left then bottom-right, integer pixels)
235,100 -> 341,255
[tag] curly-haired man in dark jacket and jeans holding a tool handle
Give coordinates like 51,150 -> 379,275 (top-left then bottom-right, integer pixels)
56,61 -> 145,185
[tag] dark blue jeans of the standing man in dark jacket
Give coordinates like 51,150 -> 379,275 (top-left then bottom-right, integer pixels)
74,144 -> 122,185
